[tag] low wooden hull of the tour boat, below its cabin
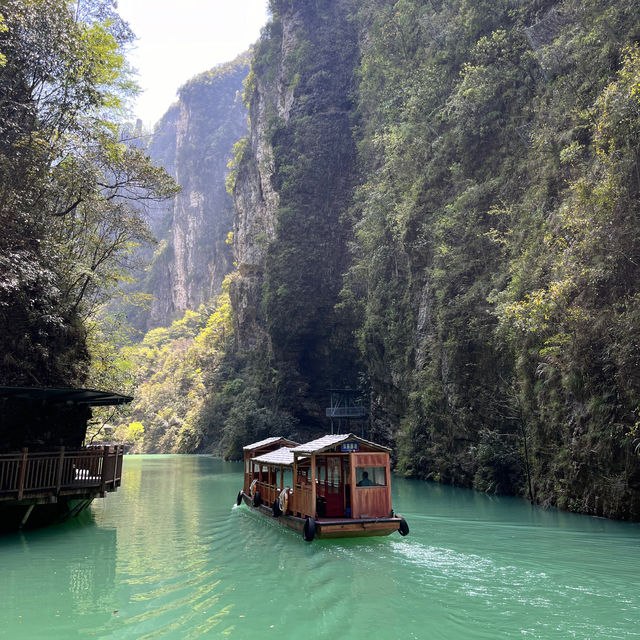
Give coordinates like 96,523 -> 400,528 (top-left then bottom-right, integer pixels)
241,492 -> 402,539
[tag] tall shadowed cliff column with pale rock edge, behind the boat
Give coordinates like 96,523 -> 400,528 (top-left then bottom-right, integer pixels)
230,0 -> 359,426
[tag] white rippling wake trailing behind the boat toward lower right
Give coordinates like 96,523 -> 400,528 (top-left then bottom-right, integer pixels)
390,540 -> 637,638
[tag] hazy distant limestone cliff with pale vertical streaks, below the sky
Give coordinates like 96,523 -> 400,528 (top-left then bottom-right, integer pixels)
141,56 -> 248,329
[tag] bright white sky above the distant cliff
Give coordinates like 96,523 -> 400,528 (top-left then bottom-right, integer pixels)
118,0 -> 267,127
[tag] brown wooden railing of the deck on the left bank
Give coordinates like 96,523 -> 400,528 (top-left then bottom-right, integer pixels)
0,445 -> 123,500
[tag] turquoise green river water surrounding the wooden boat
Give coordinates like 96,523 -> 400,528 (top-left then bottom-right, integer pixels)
0,456 -> 640,640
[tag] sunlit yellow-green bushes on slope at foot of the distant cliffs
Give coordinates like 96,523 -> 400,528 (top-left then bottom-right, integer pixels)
106,282 -> 302,458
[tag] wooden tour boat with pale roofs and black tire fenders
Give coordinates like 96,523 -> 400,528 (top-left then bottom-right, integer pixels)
237,433 -> 409,542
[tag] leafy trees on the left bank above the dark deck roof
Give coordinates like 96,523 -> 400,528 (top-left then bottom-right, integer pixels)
0,0 -> 175,385
